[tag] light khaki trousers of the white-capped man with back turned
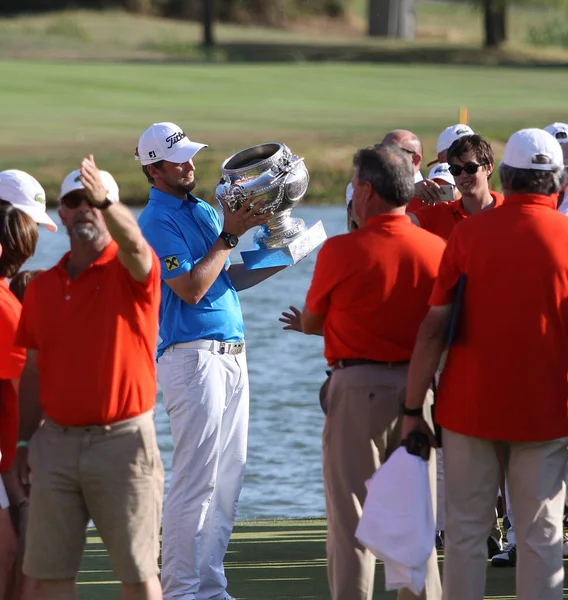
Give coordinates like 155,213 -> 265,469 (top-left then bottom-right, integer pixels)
443,429 -> 568,600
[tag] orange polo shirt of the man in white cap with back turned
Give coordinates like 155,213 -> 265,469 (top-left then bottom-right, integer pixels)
430,194 -> 568,441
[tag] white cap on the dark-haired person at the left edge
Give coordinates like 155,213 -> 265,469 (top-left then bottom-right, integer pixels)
0,169 -> 57,231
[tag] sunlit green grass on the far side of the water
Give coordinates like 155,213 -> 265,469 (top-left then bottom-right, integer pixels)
0,60 -> 568,202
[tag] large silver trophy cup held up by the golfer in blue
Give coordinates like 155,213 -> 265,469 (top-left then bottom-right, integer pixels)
215,143 -> 327,269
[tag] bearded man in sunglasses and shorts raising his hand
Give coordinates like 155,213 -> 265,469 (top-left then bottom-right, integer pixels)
16,156 -> 164,600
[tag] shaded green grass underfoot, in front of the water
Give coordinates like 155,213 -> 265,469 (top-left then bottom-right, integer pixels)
79,520 -> 568,600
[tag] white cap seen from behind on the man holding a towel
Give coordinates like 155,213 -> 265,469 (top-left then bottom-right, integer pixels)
501,129 -> 564,171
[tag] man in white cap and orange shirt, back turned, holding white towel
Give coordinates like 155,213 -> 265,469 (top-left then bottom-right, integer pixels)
403,129 -> 568,600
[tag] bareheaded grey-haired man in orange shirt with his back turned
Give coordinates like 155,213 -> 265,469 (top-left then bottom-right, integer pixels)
301,144 -> 445,600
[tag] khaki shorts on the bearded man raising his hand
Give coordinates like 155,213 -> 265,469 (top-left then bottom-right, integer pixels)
24,411 -> 164,583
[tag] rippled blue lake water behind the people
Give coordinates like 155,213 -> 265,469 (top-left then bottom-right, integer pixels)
24,206 -> 346,520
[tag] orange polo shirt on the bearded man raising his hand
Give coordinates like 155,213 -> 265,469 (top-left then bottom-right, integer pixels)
16,242 -> 160,427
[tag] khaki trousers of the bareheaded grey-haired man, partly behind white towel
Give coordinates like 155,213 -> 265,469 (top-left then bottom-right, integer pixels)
323,365 -> 442,600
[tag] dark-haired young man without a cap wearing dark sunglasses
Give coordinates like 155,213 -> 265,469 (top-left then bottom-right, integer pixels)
410,134 -> 503,240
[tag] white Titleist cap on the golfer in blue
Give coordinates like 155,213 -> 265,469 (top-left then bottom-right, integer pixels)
136,123 -> 207,165
